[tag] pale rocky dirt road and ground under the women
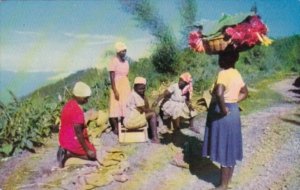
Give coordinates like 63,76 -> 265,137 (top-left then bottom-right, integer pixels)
0,78 -> 300,190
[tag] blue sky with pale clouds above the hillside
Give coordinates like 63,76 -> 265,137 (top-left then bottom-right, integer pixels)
0,0 -> 300,100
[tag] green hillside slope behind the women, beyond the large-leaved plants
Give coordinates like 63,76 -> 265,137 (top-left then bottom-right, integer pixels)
32,35 -> 300,109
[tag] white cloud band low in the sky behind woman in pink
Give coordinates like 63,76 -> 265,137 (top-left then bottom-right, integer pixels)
0,31 -> 152,72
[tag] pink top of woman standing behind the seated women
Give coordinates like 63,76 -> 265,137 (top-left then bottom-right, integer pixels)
108,57 -> 129,80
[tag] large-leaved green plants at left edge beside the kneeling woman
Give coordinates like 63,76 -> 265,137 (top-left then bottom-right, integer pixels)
0,92 -> 63,156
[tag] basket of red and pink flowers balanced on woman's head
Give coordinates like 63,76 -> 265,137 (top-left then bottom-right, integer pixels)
189,14 -> 272,54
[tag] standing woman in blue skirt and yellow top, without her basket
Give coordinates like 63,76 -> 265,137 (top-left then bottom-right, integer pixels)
202,52 -> 248,189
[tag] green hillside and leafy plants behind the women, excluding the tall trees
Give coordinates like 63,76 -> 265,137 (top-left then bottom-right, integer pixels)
0,35 -> 300,161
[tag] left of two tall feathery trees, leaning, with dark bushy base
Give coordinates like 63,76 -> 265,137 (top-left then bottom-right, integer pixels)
120,0 -> 178,73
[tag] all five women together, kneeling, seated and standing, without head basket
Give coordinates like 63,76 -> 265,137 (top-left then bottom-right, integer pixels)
57,42 -> 248,189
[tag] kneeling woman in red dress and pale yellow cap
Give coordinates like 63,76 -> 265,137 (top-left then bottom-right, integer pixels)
57,82 -> 97,168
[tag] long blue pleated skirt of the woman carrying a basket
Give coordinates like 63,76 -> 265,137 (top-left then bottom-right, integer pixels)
202,103 -> 243,167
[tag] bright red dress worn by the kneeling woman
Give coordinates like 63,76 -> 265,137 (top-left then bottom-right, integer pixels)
59,99 -> 96,155
